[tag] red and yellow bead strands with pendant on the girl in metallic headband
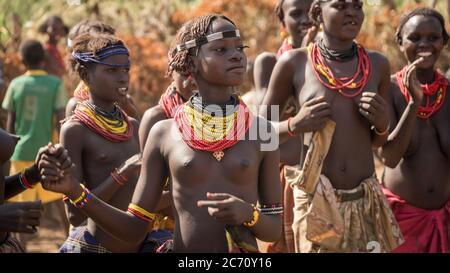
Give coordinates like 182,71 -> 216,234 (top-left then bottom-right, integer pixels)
174,94 -> 253,161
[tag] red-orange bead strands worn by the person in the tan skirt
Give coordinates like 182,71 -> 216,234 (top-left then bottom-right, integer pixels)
308,40 -> 370,98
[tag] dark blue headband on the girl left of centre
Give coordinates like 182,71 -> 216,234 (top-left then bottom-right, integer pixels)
72,44 -> 130,67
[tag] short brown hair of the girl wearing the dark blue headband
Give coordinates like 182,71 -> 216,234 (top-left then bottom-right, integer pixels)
67,33 -> 125,78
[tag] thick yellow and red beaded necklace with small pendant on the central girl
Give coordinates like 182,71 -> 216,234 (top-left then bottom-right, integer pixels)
175,93 -> 253,162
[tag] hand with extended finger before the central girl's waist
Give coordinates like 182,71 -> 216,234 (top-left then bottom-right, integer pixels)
197,192 -> 253,225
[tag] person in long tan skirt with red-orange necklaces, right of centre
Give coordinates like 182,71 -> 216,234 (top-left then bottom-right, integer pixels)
262,0 -> 402,252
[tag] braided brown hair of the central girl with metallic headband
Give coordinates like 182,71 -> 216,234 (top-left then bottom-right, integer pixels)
167,14 -> 235,75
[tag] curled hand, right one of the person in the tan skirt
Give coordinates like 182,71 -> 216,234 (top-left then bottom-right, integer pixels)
359,92 -> 389,132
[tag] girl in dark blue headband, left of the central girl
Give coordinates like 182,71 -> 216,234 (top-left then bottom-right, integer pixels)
55,34 -> 163,252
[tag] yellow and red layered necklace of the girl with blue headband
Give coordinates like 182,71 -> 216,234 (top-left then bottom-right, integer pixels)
73,101 -> 133,142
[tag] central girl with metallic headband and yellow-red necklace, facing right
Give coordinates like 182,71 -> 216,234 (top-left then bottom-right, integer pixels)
41,14 -> 282,252
